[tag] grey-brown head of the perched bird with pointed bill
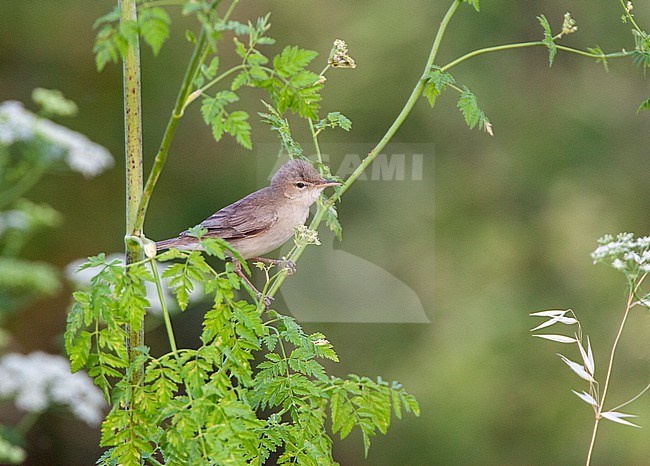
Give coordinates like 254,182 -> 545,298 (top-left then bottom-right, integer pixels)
271,159 -> 341,206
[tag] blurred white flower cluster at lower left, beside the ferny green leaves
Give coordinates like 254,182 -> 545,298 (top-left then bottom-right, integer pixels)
0,351 -> 106,426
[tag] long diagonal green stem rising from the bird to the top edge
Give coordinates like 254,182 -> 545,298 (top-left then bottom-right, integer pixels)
267,0 -> 462,297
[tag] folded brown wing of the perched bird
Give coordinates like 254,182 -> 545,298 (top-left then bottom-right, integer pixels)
194,188 -> 278,240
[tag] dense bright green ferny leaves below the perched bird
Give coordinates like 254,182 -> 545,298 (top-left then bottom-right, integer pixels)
65,239 -> 419,465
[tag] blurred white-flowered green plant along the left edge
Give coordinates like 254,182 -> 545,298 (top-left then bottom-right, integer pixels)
0,88 -> 113,464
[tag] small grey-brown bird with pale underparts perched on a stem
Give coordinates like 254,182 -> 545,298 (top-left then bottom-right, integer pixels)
156,159 -> 341,307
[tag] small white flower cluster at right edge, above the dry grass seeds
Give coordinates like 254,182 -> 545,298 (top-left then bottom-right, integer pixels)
591,233 -> 650,273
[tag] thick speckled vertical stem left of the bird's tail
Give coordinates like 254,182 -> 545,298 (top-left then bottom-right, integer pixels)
118,0 -> 144,384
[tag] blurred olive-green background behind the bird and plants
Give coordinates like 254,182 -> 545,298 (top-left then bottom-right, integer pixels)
0,0 -> 650,466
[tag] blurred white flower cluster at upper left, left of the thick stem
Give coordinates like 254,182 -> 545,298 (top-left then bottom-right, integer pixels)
0,101 -> 114,178
